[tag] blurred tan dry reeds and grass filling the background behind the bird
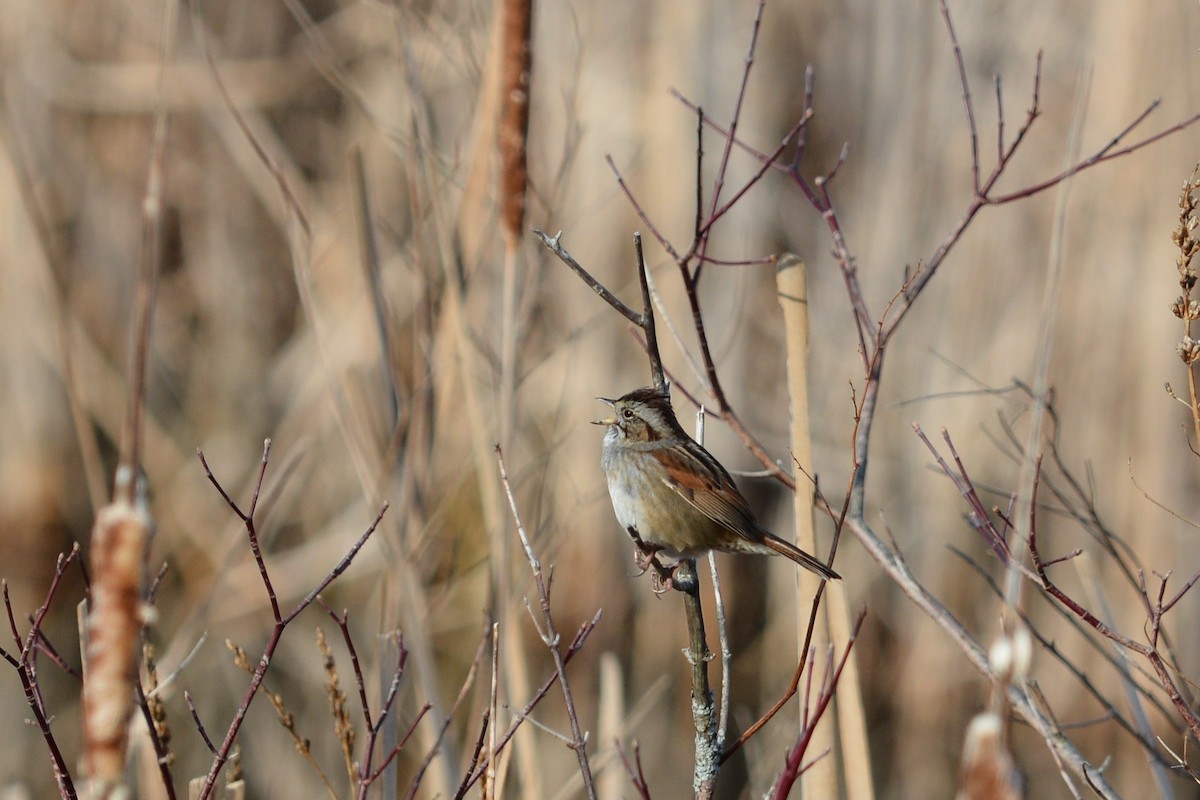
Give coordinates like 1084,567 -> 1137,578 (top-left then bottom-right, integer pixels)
0,0 -> 1200,798
